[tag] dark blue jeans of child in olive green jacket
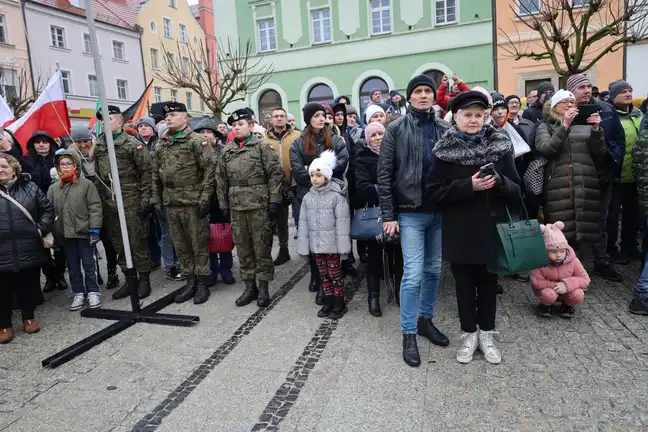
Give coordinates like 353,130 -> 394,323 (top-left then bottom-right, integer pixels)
63,239 -> 99,294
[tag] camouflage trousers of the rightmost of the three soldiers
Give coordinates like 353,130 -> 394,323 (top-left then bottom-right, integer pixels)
232,209 -> 274,281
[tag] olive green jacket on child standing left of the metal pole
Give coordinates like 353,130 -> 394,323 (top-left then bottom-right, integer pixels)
47,178 -> 103,240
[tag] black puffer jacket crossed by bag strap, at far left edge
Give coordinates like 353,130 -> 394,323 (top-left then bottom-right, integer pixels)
0,174 -> 54,272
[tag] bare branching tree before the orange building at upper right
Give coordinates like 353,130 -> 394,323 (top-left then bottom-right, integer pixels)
499,0 -> 648,77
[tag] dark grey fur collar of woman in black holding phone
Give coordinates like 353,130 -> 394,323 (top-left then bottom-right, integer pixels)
432,125 -> 513,165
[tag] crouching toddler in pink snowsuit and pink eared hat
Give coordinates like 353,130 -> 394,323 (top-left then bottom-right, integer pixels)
531,222 -> 590,319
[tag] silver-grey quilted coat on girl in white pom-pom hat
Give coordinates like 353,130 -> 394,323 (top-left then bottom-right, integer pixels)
297,178 -> 351,255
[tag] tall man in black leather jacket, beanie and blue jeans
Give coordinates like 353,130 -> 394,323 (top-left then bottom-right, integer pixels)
378,75 -> 450,366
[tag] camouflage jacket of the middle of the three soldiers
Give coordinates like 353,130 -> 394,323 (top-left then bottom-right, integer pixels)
151,127 -> 214,206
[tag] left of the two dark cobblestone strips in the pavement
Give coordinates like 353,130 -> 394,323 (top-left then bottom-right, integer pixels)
130,263 -> 310,432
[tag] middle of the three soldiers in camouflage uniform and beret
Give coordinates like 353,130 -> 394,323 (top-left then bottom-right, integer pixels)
151,102 -> 214,304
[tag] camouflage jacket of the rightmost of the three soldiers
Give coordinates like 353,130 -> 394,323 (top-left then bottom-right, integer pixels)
216,136 -> 283,210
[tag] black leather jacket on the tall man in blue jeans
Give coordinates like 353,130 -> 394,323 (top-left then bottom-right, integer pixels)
378,109 -> 450,222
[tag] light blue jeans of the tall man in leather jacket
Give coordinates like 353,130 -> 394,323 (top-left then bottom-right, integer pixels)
398,213 -> 442,334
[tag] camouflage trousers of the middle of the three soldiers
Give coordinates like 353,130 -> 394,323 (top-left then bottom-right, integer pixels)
166,206 -> 211,276
